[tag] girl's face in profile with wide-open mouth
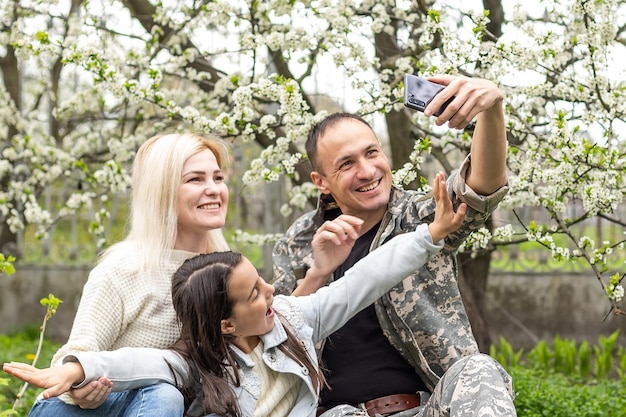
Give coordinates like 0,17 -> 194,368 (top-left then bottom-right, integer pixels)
222,257 -> 274,353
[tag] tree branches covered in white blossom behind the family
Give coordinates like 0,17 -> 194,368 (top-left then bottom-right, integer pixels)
0,0 -> 626,346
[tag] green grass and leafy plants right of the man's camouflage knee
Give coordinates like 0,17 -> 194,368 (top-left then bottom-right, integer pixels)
490,331 -> 626,417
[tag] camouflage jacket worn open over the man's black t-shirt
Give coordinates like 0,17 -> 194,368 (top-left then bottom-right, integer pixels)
273,156 -> 508,390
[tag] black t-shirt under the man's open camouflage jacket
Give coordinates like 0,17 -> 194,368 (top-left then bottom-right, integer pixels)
320,224 -> 427,408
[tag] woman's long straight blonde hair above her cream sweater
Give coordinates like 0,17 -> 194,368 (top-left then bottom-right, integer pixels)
103,133 -> 228,270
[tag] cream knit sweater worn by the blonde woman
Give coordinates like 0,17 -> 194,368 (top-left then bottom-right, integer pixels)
52,242 -> 196,366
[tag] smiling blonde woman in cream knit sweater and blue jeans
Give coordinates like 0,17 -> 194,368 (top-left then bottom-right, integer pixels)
29,134 -> 228,417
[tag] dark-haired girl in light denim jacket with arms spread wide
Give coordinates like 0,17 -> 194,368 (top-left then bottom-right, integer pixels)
3,174 -> 466,417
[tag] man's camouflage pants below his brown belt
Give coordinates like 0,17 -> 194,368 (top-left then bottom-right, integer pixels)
320,354 -> 517,417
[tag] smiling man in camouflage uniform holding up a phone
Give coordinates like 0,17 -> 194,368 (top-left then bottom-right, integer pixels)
274,76 -> 516,417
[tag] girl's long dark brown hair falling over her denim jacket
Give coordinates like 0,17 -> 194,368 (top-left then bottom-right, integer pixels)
172,251 -> 325,417
